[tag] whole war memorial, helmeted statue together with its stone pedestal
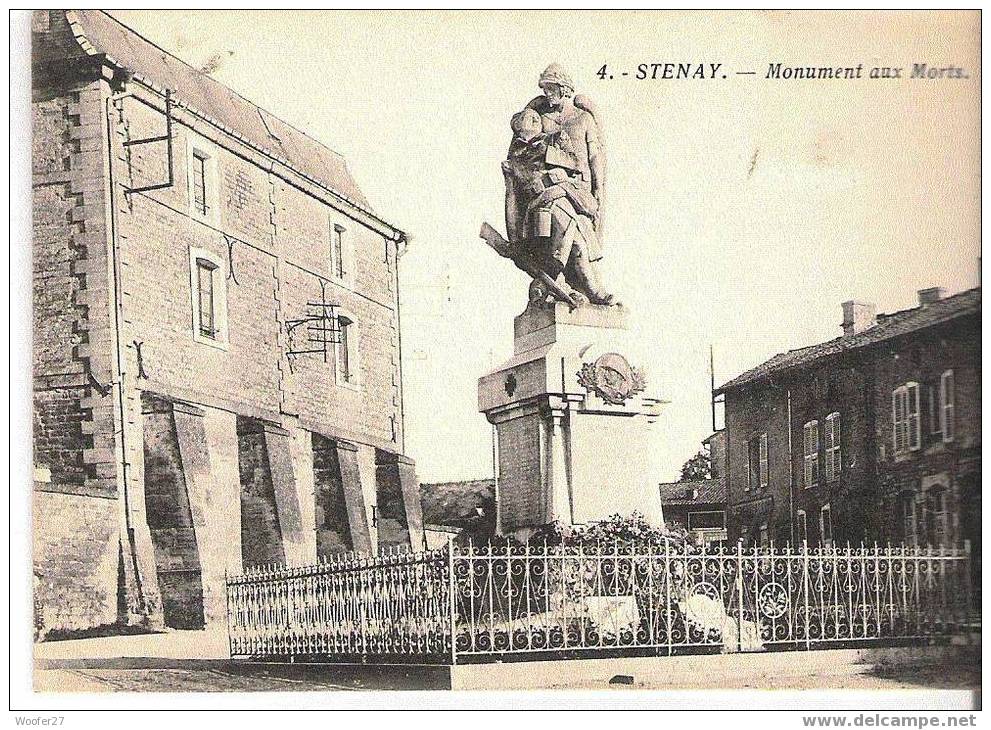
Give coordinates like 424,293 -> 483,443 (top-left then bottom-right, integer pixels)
478,64 -> 663,536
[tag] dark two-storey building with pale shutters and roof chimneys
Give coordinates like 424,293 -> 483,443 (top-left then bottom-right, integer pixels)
715,288 -> 981,547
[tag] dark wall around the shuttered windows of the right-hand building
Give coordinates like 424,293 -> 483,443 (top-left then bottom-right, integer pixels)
726,317 -> 980,545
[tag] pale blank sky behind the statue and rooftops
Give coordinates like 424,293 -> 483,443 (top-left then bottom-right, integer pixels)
112,10 -> 980,481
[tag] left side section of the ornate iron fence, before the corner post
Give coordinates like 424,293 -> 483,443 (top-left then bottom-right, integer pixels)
227,551 -> 451,662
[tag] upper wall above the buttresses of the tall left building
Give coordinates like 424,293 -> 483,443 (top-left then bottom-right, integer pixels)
114,82 -> 402,451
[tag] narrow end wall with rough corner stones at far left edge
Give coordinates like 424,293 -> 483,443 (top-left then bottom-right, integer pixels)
32,11 -> 132,631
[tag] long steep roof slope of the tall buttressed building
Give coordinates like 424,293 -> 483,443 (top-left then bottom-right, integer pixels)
60,10 -> 394,229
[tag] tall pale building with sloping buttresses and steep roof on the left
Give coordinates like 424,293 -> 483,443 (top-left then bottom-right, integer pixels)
32,11 -> 423,631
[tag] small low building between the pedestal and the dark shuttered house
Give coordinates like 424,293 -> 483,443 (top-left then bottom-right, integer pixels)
659,430 -> 727,543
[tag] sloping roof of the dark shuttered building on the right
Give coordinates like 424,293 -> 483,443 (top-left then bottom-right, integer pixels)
713,287 -> 981,395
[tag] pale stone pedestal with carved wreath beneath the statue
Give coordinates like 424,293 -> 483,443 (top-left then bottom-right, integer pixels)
478,304 -> 663,534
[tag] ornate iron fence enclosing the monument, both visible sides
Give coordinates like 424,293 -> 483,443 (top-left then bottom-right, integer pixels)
228,542 -> 970,662
